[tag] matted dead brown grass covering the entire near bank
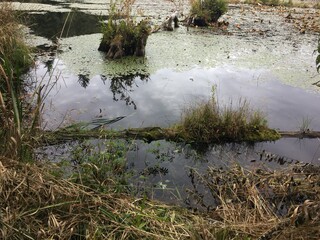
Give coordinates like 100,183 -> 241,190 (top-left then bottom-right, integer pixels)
0,158 -> 320,240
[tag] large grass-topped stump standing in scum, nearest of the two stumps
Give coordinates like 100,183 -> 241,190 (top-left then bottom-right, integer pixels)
99,0 -> 151,59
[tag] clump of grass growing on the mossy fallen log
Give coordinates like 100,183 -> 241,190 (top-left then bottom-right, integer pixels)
179,92 -> 279,143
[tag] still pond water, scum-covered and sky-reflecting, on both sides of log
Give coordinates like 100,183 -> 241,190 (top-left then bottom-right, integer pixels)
15,0 -> 320,204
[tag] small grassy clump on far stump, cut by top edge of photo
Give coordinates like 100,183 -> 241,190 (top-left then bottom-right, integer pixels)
190,0 -> 228,26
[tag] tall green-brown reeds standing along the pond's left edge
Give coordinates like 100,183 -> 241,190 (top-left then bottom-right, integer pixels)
0,3 -> 32,159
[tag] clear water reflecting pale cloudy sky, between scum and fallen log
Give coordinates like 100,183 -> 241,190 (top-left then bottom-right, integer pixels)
37,60 -> 320,163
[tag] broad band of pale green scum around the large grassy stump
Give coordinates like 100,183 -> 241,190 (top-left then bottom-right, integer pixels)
59,27 -> 319,90
